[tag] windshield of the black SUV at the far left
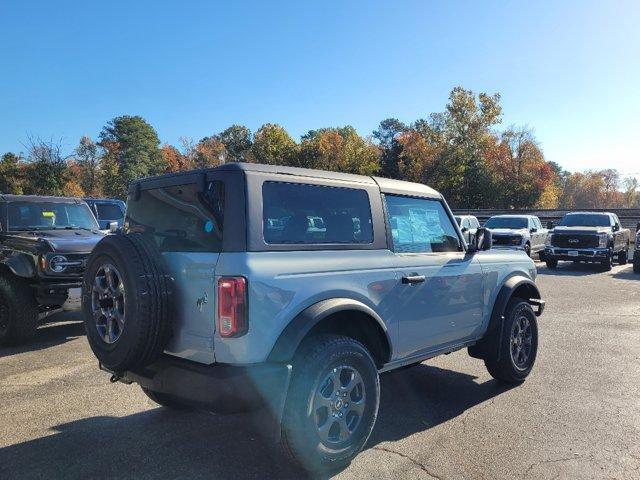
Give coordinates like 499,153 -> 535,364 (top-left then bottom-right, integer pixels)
7,202 -> 98,231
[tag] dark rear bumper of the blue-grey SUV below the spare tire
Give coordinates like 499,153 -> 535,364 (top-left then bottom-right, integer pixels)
100,354 -> 291,414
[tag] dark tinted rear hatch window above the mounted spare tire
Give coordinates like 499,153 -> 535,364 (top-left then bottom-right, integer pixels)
125,181 -> 224,252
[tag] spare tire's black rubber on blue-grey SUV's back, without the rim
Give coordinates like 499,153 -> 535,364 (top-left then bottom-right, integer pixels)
82,233 -> 172,372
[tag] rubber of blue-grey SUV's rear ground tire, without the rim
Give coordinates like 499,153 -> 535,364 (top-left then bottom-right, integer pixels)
282,335 -> 380,472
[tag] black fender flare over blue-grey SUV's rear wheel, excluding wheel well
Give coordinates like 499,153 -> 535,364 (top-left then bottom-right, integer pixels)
268,298 -> 393,362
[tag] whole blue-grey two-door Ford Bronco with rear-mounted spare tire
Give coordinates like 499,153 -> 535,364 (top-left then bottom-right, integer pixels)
82,163 -> 544,470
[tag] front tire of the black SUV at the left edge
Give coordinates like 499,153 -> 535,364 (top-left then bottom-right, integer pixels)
0,274 -> 38,345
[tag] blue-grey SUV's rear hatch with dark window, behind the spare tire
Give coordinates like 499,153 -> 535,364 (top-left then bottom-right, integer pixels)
125,177 -> 224,363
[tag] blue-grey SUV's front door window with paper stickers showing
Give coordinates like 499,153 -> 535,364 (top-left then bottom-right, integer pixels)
385,195 -> 462,253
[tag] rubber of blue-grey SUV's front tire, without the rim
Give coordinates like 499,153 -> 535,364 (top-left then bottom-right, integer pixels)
484,298 -> 538,383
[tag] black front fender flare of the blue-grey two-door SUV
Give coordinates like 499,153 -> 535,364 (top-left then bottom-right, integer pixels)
468,275 -> 545,359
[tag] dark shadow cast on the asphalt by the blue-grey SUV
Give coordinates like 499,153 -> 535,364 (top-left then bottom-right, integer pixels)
0,365 -> 508,480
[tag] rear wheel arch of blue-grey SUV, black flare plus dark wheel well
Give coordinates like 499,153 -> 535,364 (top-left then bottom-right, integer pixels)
268,298 -> 392,367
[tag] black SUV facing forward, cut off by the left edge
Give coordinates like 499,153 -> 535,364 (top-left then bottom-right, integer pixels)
0,194 -> 104,344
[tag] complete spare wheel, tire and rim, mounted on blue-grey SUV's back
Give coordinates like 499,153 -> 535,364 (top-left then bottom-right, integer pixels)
82,233 -> 171,372
